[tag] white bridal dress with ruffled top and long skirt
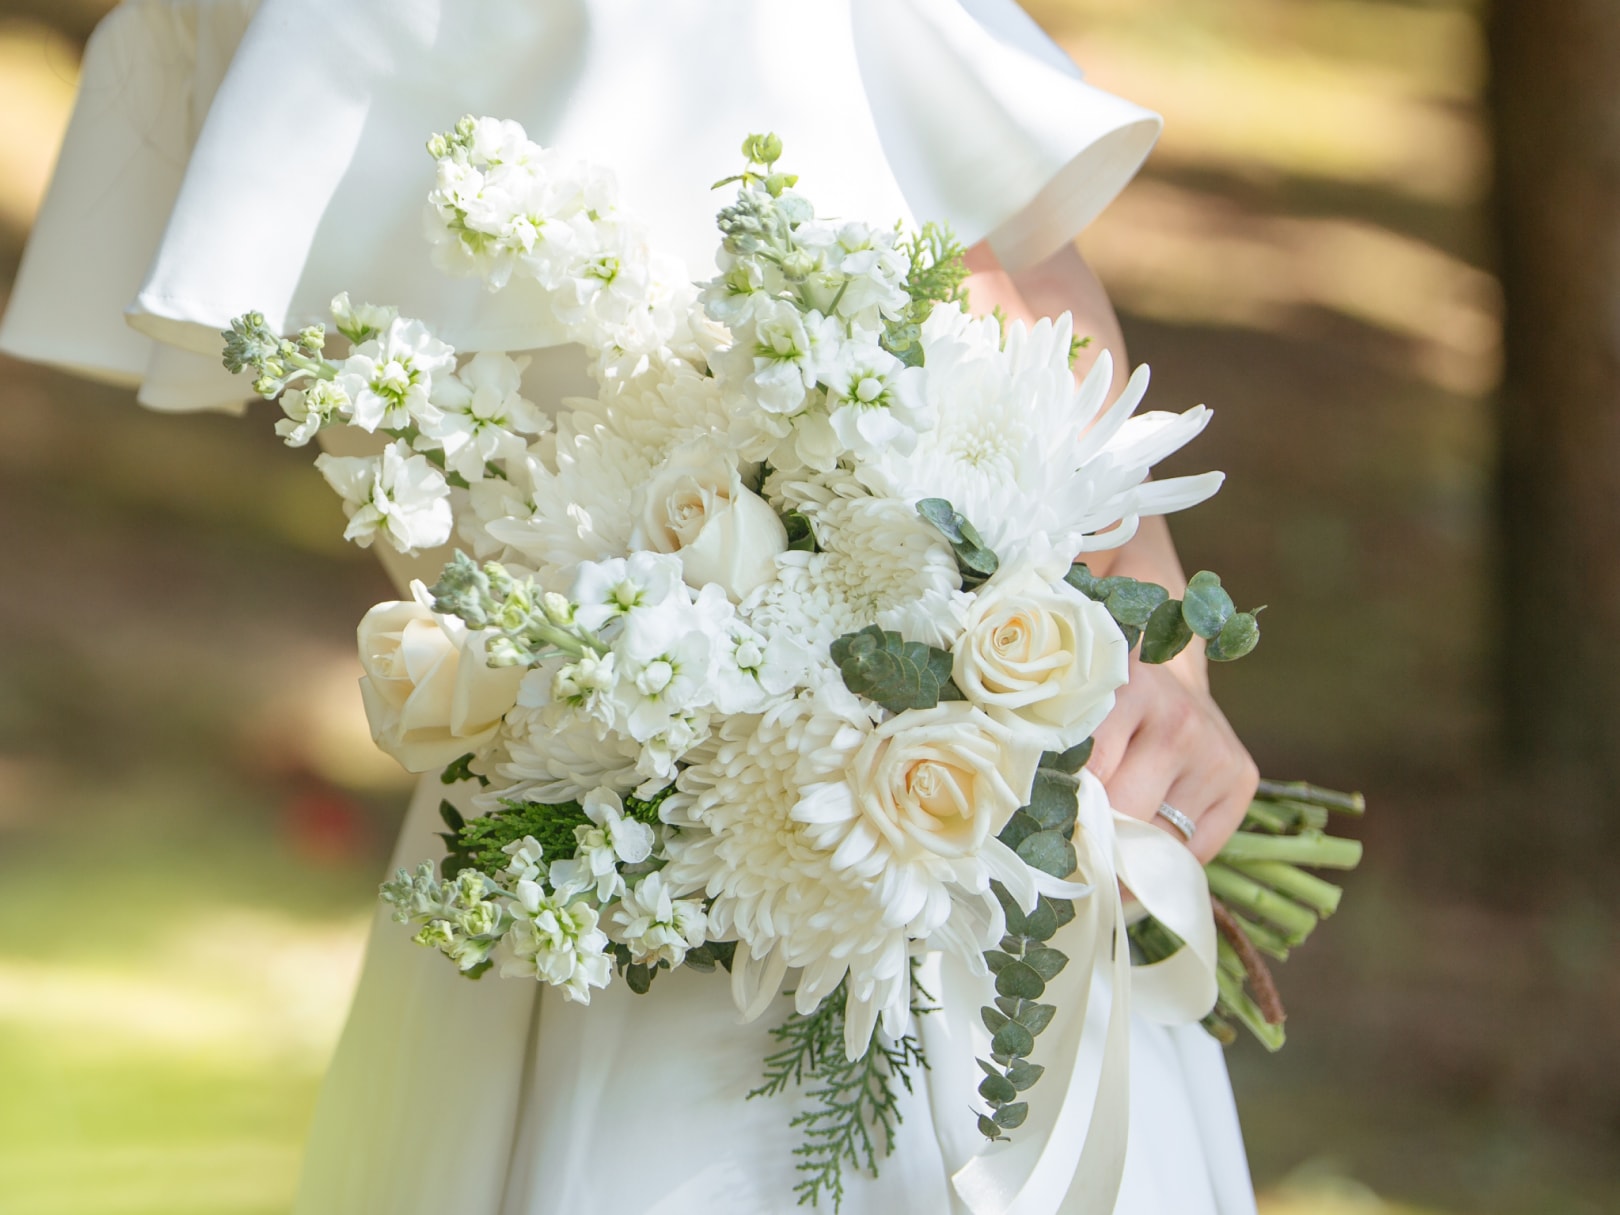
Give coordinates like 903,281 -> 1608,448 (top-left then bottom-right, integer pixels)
0,0 -> 1254,1215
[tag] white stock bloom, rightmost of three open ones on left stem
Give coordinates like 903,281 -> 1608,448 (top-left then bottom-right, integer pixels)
421,350 -> 551,483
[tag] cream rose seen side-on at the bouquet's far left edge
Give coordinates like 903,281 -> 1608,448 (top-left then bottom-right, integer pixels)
360,582 -> 523,773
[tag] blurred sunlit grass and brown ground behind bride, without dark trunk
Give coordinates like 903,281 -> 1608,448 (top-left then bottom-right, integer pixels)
0,0 -> 1620,1215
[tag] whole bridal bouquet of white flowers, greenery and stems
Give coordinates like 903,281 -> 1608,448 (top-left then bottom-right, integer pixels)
225,118 -> 1356,1204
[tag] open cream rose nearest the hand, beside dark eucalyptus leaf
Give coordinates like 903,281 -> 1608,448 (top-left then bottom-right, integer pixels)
951,562 -> 1131,750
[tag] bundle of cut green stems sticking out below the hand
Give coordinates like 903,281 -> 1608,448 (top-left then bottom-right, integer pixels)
1131,781 -> 1367,1050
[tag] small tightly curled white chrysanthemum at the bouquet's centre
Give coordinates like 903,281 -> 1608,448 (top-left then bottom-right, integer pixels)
742,497 -> 962,654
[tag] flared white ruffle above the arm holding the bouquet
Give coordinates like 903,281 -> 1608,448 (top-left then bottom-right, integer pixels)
854,0 -> 1162,271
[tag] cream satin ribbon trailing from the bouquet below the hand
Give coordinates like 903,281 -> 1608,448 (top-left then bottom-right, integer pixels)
923,771 -> 1215,1215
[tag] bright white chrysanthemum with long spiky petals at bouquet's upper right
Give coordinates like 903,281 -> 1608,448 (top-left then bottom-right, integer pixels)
859,305 -> 1221,567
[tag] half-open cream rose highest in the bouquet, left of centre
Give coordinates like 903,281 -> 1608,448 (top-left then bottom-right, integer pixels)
630,439 -> 787,601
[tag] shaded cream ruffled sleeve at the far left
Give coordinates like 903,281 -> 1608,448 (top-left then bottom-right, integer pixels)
0,0 -> 254,408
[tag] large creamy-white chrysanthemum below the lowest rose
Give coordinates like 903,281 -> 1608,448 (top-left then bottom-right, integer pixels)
663,689 -> 910,1056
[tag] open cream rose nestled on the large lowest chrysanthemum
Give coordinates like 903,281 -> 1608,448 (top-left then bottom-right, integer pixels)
846,700 -> 1042,860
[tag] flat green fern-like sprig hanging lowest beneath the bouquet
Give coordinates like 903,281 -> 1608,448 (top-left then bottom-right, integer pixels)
748,967 -> 932,1212
